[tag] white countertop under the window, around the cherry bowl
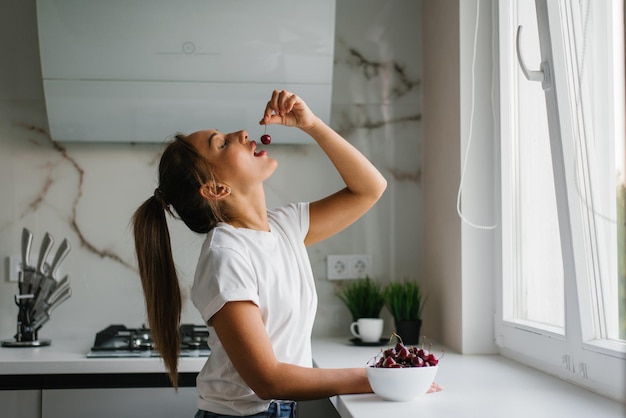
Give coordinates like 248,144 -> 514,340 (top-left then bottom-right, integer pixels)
313,338 -> 626,418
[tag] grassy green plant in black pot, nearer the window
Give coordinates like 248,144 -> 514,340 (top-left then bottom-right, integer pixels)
383,279 -> 426,344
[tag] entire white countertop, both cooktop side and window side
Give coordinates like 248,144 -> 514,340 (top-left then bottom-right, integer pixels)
0,337 -> 626,418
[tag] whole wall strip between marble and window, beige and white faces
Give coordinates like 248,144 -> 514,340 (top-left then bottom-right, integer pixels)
423,0 -> 499,354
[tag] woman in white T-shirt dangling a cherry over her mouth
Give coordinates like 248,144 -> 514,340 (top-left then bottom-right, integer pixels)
133,91 -> 387,417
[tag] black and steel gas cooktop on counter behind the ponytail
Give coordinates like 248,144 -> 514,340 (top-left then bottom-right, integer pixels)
87,324 -> 211,358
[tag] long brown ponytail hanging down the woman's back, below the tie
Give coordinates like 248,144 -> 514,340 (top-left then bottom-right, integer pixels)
133,191 -> 182,388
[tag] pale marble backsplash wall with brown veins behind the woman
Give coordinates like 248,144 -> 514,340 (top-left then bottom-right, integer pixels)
0,0 -> 423,340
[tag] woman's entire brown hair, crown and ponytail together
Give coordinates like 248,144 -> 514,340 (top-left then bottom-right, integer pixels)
132,134 -> 226,388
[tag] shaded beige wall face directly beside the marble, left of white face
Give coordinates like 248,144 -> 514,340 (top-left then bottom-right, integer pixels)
423,0 -> 462,350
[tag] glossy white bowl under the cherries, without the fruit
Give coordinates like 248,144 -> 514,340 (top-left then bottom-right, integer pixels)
365,366 -> 439,401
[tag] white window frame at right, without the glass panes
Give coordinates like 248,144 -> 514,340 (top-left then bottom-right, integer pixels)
495,0 -> 626,401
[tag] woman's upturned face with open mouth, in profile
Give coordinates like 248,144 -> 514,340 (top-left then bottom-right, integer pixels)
187,129 -> 278,192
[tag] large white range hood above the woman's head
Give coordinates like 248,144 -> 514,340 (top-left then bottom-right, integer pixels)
37,0 -> 335,143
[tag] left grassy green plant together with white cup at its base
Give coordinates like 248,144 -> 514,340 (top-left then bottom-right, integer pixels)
338,277 -> 385,344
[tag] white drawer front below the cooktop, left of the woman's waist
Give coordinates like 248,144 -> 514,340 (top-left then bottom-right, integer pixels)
41,387 -> 198,418
